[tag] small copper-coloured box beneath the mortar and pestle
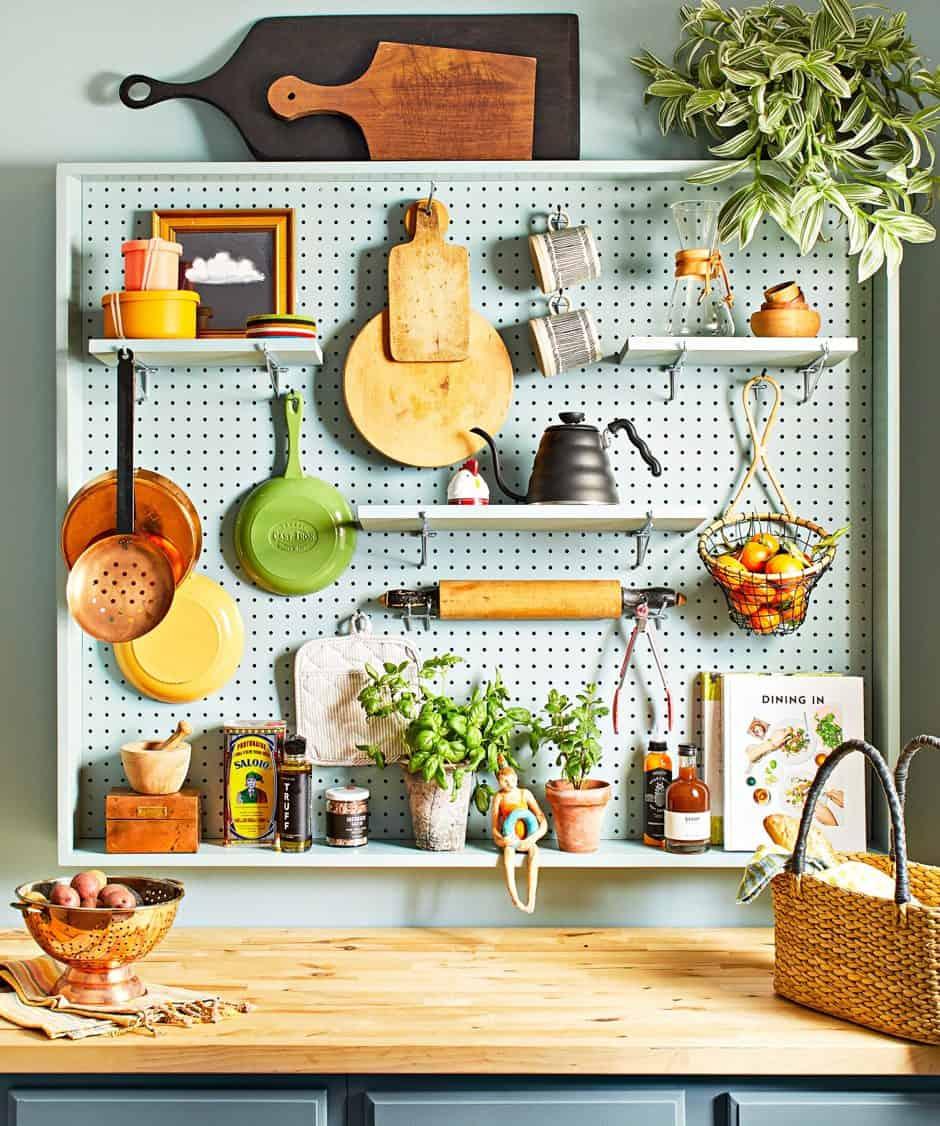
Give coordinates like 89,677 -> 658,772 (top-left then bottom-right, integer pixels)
105,788 -> 200,852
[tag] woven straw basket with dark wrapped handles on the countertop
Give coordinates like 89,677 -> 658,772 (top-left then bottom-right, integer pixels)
771,735 -> 940,1044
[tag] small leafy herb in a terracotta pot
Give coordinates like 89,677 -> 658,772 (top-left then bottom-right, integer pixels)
530,685 -> 610,852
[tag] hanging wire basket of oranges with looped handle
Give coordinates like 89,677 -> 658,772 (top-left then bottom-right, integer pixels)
698,373 -> 840,634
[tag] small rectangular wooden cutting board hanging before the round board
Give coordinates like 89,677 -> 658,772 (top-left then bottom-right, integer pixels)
388,199 -> 469,364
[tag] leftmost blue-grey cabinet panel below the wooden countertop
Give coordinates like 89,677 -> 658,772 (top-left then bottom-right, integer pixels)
10,1087 -> 326,1126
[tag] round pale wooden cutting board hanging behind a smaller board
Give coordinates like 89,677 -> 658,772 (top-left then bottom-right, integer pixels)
343,310 -> 512,467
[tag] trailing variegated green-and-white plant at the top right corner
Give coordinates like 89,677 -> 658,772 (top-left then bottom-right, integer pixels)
633,0 -> 940,280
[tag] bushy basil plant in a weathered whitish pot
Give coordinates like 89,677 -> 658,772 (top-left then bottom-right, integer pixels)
358,653 -> 531,851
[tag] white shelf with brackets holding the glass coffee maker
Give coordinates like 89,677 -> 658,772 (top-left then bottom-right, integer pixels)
619,337 -> 859,403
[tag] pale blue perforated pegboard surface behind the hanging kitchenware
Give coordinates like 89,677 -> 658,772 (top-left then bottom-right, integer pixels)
60,164 -> 872,839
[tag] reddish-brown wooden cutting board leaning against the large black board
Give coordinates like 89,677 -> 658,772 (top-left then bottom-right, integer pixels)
268,43 -> 536,160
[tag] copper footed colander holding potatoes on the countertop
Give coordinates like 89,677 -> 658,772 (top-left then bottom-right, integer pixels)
11,876 -> 185,1004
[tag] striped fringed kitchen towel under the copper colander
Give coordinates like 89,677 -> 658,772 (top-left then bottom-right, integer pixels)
0,955 -> 249,1040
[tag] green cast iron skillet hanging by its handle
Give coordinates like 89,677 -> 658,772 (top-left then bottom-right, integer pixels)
235,391 -> 356,595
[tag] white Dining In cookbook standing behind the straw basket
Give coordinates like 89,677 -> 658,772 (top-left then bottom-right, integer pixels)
720,673 -> 867,852
